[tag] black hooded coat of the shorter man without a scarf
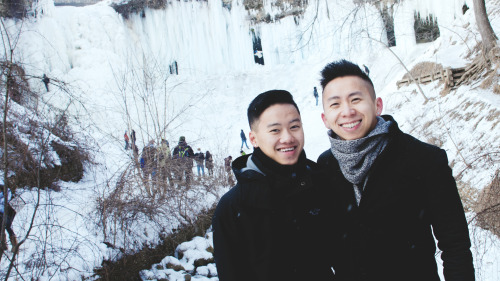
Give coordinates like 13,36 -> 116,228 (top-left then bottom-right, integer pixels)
212,149 -> 342,281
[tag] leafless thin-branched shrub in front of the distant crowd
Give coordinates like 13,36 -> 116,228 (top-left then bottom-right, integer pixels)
94,48 -> 226,258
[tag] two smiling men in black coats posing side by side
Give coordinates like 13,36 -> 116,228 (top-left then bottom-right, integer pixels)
212,60 -> 475,281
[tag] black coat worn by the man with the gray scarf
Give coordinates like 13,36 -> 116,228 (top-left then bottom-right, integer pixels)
318,116 -> 474,281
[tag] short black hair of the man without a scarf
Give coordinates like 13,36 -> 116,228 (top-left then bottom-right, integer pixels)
247,90 -> 300,129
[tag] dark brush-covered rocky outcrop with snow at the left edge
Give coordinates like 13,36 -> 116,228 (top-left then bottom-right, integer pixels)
0,62 -> 89,190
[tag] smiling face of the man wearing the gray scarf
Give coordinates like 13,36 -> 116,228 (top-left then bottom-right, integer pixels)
321,76 -> 383,140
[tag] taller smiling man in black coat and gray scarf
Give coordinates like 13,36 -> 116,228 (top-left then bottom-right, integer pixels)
318,60 -> 474,281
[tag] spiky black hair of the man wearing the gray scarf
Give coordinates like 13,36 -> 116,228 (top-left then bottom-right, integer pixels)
320,60 -> 376,99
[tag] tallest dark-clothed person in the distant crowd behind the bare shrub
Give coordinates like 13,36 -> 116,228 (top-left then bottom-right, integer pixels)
172,136 -> 194,185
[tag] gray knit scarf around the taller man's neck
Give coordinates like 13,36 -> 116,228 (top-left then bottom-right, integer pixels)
328,116 -> 392,205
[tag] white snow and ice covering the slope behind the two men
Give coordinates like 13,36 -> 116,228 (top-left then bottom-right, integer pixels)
1,0 -> 500,281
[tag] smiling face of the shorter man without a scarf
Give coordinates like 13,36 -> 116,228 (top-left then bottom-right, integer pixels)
249,104 -> 304,165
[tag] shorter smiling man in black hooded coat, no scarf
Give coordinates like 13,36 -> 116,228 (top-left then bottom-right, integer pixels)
212,90 -> 335,281
